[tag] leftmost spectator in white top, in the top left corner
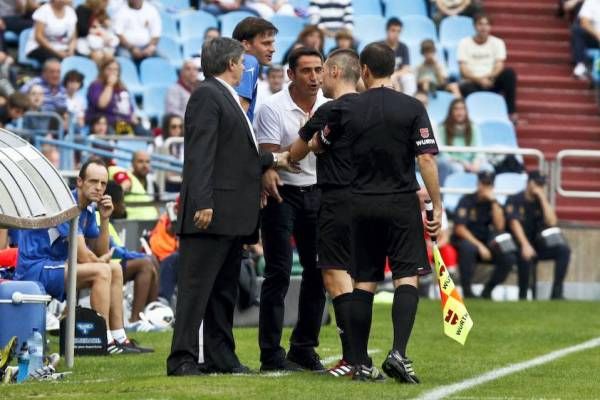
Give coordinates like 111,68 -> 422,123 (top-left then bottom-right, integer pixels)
25,0 -> 77,64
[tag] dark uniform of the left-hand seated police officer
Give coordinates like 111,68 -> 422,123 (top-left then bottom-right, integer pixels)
452,193 -> 516,297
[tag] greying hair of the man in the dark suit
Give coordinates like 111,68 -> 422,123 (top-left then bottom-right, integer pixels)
201,37 -> 244,78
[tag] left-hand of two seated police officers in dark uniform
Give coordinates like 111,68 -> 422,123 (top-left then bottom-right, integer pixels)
452,171 -> 517,299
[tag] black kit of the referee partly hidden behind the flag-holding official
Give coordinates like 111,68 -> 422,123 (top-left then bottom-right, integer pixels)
299,93 -> 358,270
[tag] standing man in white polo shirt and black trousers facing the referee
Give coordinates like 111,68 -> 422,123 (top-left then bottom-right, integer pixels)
254,47 -> 326,371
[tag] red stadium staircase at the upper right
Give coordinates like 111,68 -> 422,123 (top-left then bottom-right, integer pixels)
485,0 -> 600,225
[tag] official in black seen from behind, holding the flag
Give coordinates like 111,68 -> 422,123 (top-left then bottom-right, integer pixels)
326,43 -> 442,383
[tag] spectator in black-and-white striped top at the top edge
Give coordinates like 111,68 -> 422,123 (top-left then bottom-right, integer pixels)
308,0 -> 354,37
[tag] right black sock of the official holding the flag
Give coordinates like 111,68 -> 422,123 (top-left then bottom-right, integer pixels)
392,285 -> 419,357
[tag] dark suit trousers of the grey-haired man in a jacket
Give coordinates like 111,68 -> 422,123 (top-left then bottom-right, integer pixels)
167,234 -> 242,372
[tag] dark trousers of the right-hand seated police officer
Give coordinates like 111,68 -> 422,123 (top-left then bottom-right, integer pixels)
517,244 -> 571,299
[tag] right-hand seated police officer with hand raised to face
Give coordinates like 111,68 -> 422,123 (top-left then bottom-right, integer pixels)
505,170 -> 571,299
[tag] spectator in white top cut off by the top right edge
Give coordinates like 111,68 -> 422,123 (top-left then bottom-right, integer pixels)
571,0 -> 600,79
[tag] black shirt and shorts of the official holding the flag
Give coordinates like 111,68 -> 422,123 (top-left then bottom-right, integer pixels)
326,87 -> 438,282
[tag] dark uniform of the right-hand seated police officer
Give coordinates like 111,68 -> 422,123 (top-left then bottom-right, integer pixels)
504,191 -> 571,299
